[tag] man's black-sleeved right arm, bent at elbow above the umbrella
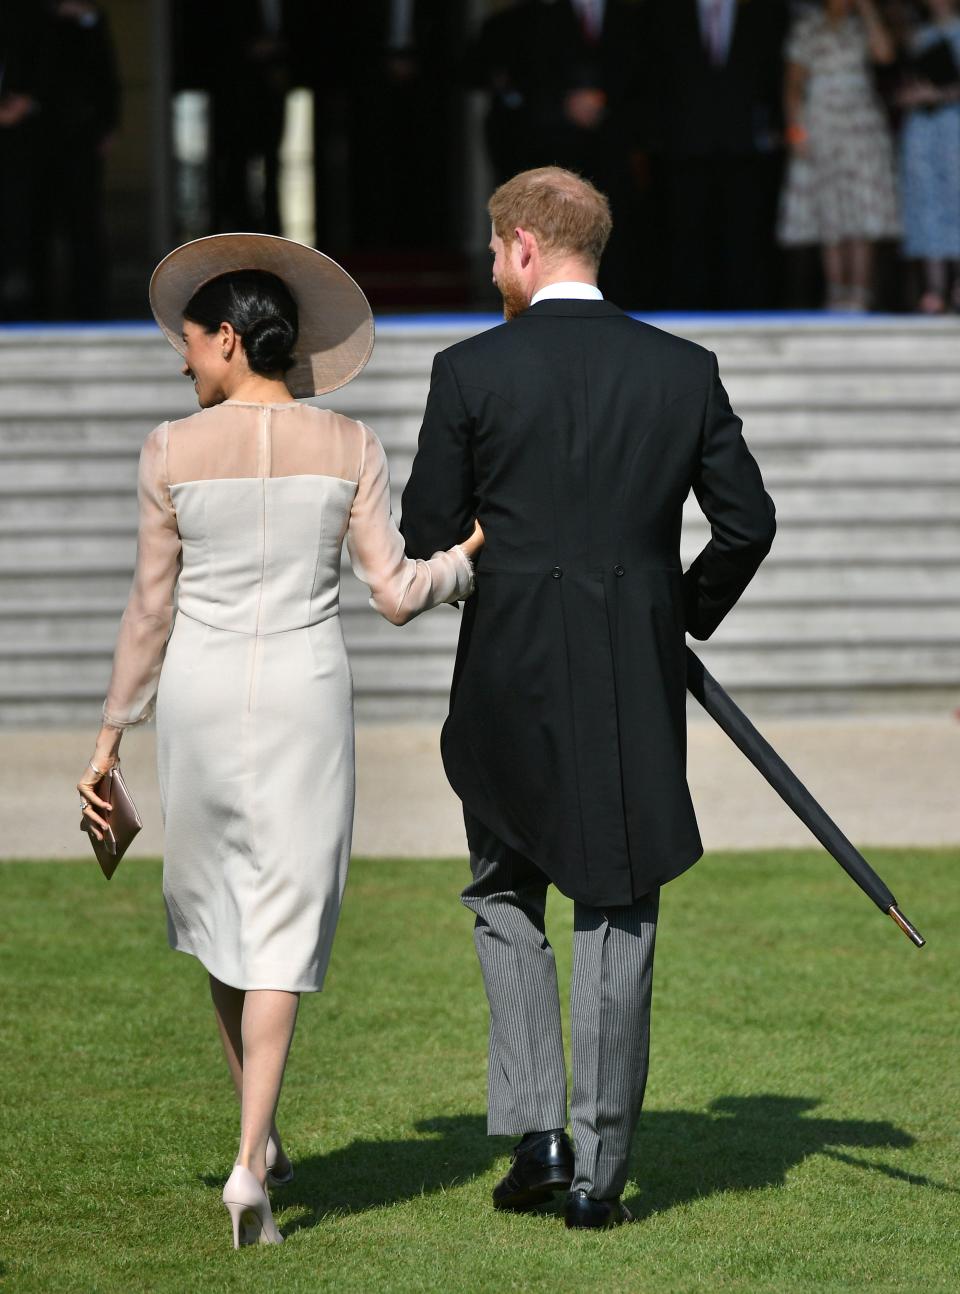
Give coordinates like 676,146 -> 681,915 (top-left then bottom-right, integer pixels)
683,356 -> 776,638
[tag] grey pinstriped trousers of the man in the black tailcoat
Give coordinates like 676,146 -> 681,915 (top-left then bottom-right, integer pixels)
462,811 -> 660,1200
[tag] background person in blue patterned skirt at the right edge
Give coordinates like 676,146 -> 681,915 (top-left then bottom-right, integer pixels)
898,0 -> 960,314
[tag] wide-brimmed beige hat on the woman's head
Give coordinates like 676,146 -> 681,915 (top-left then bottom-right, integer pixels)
150,234 -> 374,399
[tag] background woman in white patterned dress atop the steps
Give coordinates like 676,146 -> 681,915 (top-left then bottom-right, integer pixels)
779,0 -> 900,311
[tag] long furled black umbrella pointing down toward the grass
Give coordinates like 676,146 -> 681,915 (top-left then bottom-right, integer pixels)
687,647 -> 926,949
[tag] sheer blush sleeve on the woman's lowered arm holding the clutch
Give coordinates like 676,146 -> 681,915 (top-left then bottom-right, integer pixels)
104,422 -> 180,729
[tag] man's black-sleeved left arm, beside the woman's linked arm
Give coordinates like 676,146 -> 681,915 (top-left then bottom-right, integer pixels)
400,351 -> 476,558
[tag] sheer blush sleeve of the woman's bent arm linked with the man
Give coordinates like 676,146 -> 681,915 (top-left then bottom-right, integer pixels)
347,423 -> 474,625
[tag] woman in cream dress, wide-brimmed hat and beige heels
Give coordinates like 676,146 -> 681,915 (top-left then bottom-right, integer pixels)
79,234 -> 481,1244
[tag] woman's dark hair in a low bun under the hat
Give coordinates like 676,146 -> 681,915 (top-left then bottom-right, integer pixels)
184,269 -> 300,377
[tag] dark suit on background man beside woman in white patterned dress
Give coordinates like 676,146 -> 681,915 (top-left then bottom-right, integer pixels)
644,0 -> 787,309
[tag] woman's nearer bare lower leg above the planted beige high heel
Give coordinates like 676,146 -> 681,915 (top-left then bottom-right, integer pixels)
237,989 -> 300,1184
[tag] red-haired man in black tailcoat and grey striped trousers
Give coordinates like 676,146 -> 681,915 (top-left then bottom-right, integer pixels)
402,167 -> 774,1227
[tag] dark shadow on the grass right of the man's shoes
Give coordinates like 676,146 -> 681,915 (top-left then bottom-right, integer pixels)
626,1095 -> 955,1218
